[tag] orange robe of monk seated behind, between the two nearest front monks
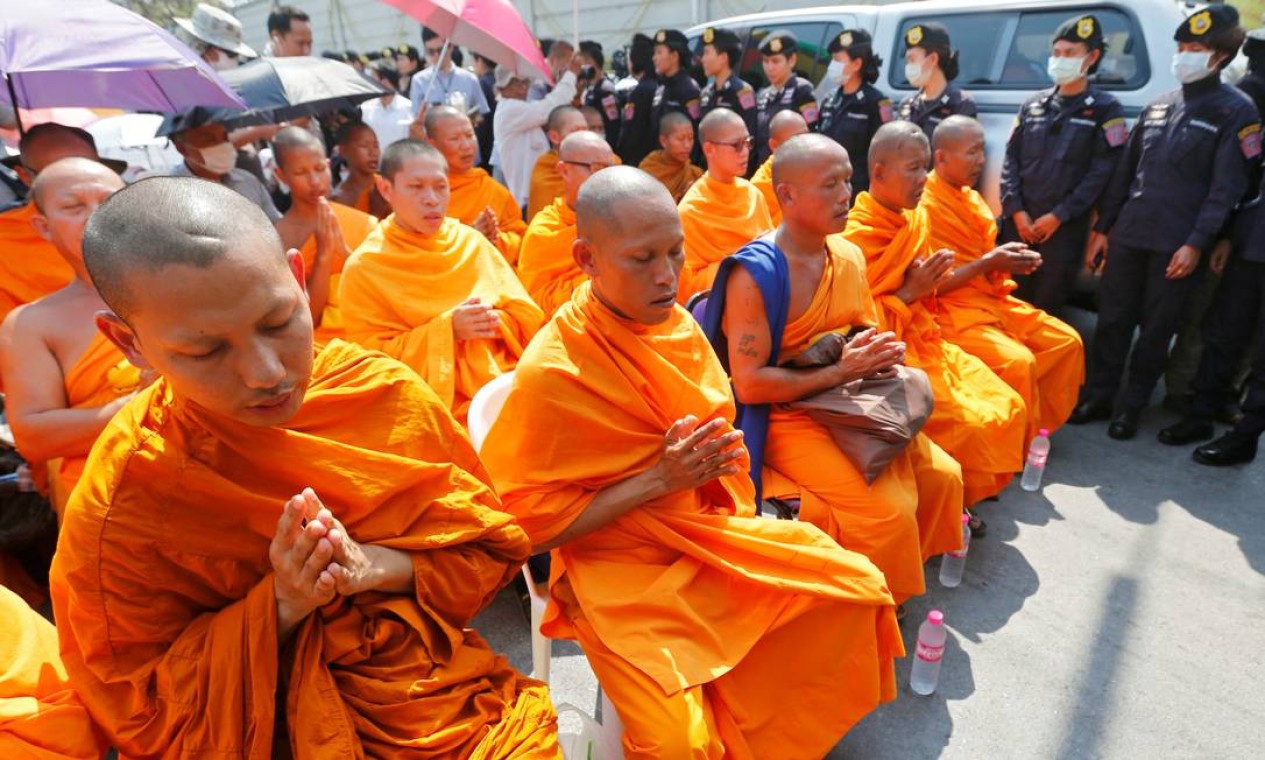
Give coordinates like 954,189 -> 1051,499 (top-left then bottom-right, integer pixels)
340,215 -> 544,420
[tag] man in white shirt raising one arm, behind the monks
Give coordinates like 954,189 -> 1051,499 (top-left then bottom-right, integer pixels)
492,56 -> 579,206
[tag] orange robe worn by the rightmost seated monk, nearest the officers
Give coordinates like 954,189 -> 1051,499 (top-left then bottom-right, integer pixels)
921,172 -> 1085,438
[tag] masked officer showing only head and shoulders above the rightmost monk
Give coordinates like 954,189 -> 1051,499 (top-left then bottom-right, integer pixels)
896,23 -> 977,140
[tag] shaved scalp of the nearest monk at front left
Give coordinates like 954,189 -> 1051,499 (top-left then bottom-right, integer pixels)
83,177 -> 287,319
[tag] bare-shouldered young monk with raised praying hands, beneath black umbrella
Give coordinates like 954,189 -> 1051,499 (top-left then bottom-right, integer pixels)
272,126 -> 378,344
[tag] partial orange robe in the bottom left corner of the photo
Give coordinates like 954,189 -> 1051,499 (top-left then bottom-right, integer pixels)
0,585 -> 106,760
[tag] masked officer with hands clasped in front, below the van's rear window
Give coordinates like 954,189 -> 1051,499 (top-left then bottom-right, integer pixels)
1002,15 -> 1128,312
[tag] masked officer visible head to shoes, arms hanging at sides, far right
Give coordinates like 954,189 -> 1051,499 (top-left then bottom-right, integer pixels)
1069,5 -> 1261,440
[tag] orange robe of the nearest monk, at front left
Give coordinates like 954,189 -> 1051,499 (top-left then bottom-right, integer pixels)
52,340 -> 560,760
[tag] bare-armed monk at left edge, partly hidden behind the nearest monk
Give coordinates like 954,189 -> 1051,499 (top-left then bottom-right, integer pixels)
0,158 -> 140,516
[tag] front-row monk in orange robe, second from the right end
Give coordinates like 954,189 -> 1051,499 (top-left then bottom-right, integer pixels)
844,121 -> 1027,515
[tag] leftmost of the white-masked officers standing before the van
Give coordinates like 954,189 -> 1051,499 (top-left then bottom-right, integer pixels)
817,29 -> 893,197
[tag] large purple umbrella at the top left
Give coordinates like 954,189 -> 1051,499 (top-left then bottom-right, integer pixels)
0,0 -> 247,122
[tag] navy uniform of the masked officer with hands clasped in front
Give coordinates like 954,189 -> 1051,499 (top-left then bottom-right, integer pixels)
1002,86 -> 1128,311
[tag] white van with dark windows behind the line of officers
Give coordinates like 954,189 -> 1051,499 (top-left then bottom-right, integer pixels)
686,0 -> 1194,210
